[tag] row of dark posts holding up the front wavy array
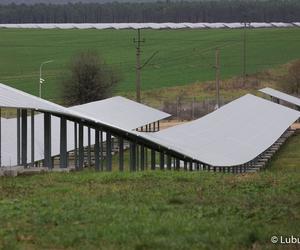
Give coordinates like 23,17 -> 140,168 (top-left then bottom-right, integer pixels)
0,109 -> 246,173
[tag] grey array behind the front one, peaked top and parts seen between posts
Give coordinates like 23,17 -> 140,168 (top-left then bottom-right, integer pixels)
2,96 -> 170,166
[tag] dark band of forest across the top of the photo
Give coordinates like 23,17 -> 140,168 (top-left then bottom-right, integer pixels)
0,0 -> 300,23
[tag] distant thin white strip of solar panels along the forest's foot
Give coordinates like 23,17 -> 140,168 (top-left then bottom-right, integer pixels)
0,22 -> 300,30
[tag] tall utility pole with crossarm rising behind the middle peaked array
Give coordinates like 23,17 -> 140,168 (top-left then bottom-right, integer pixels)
133,29 -> 145,102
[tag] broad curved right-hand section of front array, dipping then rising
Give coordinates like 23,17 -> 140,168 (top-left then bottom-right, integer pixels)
141,94 -> 300,167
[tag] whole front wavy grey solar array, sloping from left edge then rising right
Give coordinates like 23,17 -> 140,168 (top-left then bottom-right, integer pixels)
0,84 -> 300,167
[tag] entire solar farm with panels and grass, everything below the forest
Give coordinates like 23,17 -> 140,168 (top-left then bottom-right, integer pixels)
0,23 -> 300,250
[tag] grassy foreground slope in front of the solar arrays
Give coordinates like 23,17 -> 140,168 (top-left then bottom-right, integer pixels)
0,133 -> 300,249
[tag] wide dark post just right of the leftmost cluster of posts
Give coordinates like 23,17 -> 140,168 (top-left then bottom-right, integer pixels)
44,113 -> 52,169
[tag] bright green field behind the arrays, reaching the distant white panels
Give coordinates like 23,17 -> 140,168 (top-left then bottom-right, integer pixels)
0,28 -> 300,100
